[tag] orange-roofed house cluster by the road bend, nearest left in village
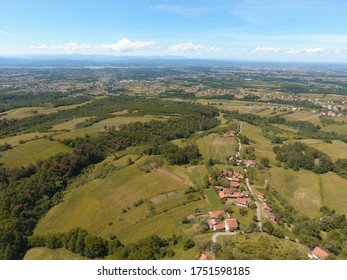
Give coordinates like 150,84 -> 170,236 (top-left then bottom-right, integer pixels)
207,210 -> 239,231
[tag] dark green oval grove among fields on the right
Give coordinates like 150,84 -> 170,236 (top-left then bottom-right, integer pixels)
273,142 -> 334,174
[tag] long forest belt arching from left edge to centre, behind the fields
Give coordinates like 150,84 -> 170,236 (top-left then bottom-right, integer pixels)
0,96 -> 218,137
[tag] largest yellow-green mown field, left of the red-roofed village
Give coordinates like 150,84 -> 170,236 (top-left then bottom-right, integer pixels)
35,160 -> 199,245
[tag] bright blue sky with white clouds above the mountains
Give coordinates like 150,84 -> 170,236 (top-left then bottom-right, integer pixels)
0,0 -> 347,62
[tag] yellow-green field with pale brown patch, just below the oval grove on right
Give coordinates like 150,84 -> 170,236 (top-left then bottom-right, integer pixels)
270,167 -> 323,217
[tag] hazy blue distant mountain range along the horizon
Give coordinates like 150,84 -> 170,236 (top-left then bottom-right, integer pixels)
0,54 -> 347,70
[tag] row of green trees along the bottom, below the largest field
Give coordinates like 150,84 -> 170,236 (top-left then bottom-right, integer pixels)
29,228 -> 195,260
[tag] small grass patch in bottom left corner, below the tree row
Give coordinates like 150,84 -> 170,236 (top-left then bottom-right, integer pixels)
24,247 -> 88,260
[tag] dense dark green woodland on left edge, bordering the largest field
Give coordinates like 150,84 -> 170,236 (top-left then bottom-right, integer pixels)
0,145 -> 103,259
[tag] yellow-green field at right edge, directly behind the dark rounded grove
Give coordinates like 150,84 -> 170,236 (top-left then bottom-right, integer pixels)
288,139 -> 347,161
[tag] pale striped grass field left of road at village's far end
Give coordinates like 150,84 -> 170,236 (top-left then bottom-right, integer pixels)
196,133 -> 238,162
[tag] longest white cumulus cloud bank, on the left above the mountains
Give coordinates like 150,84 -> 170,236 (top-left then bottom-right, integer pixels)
29,38 -> 156,54
